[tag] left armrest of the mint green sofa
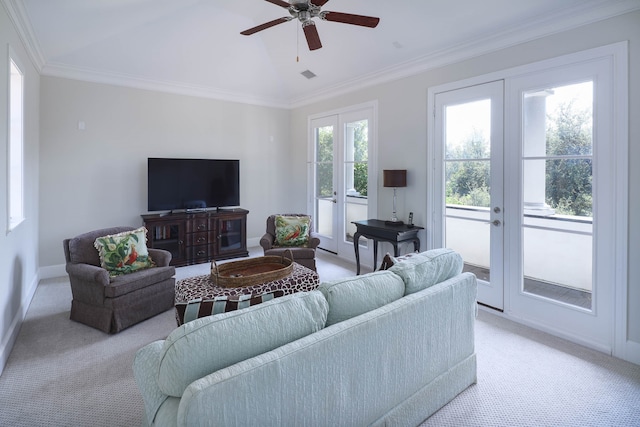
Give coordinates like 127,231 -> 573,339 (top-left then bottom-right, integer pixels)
133,340 -> 169,425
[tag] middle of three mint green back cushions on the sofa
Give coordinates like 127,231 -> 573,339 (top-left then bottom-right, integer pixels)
318,271 -> 405,326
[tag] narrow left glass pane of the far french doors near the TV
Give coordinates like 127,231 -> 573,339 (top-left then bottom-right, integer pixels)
314,126 -> 334,236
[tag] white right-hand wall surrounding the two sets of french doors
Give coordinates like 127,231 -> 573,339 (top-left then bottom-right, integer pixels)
291,12 -> 640,363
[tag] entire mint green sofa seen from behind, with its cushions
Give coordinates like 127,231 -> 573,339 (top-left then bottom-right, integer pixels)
133,249 -> 477,427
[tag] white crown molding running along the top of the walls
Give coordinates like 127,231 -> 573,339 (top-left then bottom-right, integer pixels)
6,0 -> 640,109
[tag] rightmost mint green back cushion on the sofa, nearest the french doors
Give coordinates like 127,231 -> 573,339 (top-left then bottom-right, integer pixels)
386,248 -> 464,295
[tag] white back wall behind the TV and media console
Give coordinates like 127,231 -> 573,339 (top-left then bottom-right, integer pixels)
39,77 -> 292,273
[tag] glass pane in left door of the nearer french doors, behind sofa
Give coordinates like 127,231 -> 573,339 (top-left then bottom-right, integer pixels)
444,99 -> 491,281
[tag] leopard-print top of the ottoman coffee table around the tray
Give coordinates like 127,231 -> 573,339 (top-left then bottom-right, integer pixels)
175,263 -> 320,303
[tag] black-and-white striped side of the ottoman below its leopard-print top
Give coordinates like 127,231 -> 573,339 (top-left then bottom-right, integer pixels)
175,289 -> 284,326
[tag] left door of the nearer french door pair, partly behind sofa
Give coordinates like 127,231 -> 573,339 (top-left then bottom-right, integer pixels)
433,81 -> 504,310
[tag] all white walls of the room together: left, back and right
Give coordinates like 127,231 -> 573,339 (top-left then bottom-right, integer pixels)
0,8 -> 640,370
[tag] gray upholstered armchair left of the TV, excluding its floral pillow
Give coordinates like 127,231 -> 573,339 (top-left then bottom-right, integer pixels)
63,227 -> 175,333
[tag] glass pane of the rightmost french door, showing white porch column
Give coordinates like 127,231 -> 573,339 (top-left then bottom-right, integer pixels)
522,81 -> 593,309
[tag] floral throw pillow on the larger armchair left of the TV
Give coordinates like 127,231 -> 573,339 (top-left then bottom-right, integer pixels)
93,227 -> 155,277
